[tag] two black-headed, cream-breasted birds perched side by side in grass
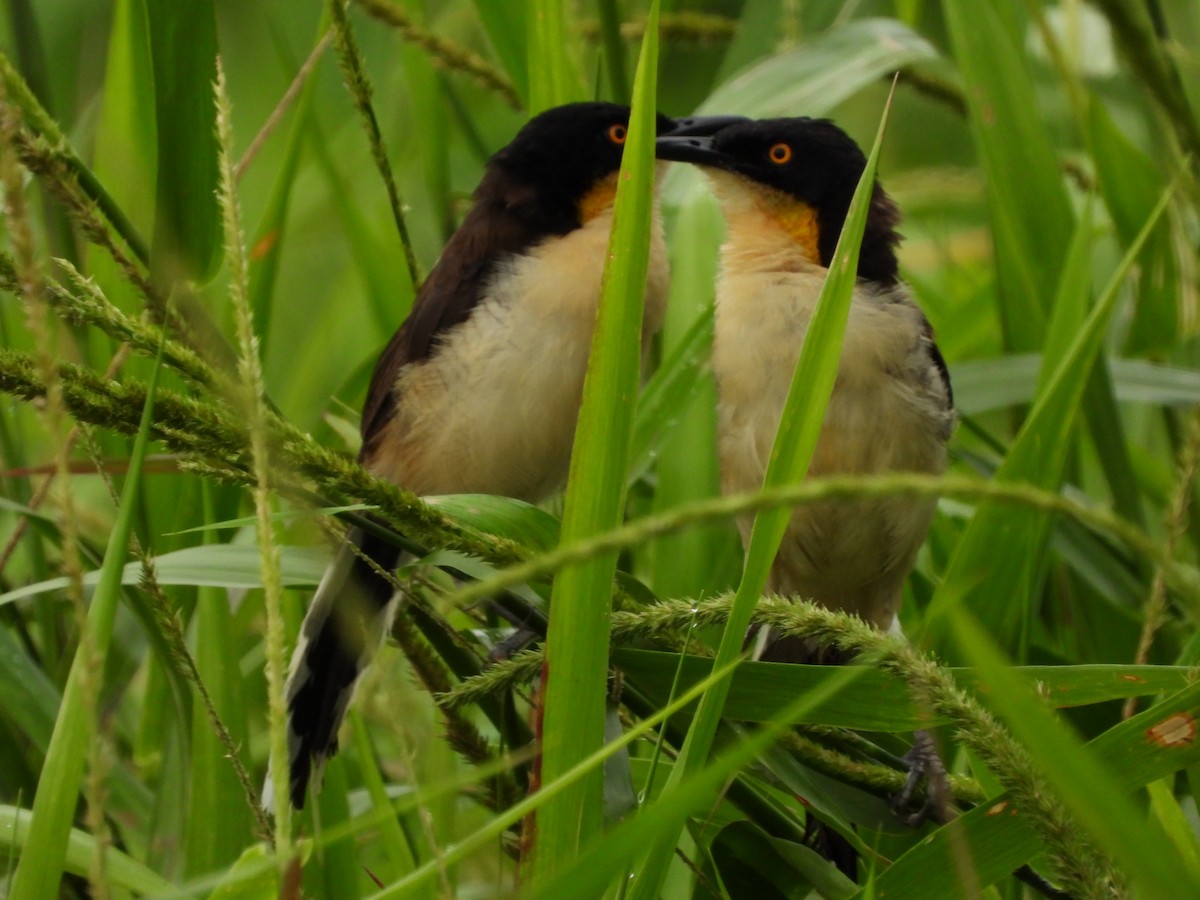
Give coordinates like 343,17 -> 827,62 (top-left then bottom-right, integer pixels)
276,103 -> 954,808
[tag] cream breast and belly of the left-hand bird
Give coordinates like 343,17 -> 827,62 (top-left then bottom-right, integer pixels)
373,202 -> 667,502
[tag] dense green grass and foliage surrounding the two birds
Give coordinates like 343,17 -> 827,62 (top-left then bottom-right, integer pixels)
0,0 -> 1200,898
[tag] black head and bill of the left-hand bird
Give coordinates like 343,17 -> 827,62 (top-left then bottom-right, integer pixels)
480,102 -> 733,234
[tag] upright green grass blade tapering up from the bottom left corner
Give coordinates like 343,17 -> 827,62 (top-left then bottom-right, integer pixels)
10,348 -> 160,900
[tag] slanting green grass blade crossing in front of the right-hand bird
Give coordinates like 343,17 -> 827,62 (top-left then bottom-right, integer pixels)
630,81 -> 890,900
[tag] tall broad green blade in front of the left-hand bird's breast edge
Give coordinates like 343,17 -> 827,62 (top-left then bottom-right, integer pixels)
534,2 -> 658,877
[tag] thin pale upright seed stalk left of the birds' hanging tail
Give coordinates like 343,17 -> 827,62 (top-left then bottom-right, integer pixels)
214,56 -> 294,854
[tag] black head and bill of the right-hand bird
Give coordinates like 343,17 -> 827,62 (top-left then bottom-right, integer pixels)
656,118 -> 899,283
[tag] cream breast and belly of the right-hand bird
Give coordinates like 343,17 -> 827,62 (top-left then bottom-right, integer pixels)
713,268 -> 948,628
